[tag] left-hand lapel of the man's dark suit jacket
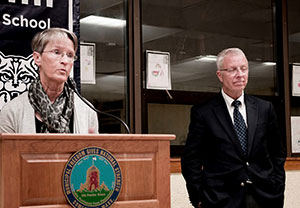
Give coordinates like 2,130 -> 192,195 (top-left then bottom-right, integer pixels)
214,93 -> 244,157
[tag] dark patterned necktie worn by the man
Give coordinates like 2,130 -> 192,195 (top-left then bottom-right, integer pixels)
231,100 -> 247,154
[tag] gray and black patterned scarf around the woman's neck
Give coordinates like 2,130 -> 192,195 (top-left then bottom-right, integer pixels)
28,78 -> 75,133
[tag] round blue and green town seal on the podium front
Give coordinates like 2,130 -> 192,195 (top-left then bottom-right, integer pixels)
62,147 -> 122,208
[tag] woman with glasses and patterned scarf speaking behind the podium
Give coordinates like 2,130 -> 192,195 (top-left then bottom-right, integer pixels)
0,28 -> 98,134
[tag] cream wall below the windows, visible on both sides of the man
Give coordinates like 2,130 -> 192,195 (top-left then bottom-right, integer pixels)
171,171 -> 300,208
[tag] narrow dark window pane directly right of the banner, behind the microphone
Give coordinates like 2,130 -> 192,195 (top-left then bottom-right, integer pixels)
80,0 -> 127,133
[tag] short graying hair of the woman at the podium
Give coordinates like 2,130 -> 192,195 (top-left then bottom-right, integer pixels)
31,27 -> 78,53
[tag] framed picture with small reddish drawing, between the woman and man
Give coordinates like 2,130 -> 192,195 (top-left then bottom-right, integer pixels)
146,50 -> 171,90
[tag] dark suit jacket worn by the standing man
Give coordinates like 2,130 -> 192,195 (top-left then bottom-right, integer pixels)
181,93 -> 286,208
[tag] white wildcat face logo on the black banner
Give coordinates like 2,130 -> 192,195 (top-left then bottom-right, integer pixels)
0,51 -> 38,109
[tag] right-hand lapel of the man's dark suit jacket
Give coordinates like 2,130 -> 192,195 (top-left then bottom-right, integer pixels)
245,95 -> 258,155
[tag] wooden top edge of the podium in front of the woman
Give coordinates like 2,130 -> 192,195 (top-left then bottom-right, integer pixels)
0,133 -> 176,140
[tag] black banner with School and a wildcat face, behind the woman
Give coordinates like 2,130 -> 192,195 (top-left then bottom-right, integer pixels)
0,0 -> 80,110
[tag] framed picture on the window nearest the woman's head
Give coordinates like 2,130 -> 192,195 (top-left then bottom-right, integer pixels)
80,43 -> 96,84
